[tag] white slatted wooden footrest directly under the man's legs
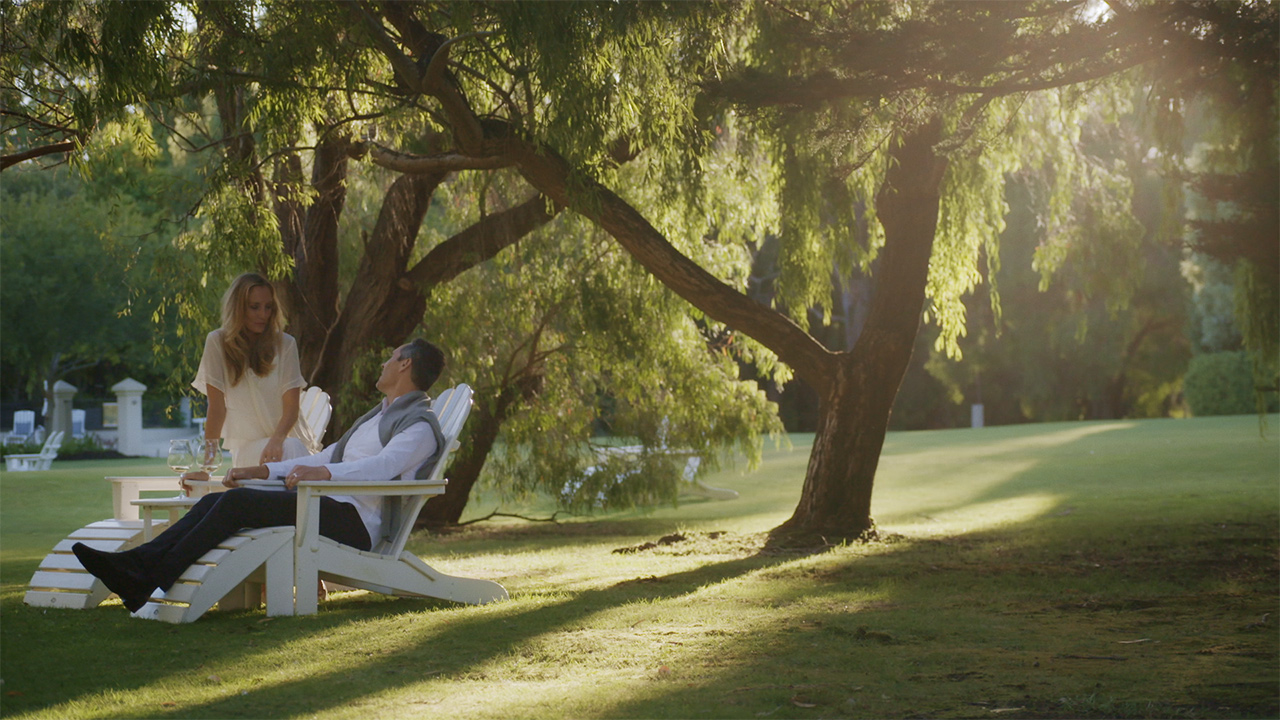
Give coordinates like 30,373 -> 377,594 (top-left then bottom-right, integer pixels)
133,525 -> 293,623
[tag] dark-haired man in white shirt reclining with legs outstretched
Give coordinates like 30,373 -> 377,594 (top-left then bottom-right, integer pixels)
72,340 -> 444,612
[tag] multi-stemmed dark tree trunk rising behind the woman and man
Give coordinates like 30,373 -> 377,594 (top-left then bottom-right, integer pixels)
274,141 -> 559,437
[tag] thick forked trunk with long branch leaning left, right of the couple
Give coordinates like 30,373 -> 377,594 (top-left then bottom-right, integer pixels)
518,120 -> 946,543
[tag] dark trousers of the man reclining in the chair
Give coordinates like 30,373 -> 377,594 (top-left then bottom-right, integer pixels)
127,488 -> 372,591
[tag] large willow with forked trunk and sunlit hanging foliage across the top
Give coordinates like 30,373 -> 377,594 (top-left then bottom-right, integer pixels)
7,0 -> 1275,542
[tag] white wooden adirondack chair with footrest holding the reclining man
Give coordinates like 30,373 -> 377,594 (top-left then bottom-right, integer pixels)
134,384 -> 507,623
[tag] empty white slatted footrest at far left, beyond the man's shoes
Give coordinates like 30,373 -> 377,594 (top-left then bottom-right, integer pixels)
23,520 -> 166,610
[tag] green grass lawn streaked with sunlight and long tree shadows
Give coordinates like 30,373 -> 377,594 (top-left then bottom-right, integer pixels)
0,416 -> 1280,720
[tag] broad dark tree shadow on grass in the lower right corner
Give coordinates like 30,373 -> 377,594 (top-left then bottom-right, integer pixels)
594,516 -> 1280,717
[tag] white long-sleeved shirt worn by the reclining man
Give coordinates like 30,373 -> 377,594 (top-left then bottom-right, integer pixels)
266,398 -> 435,547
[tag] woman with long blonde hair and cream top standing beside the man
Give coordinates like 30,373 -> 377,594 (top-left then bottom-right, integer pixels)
191,273 -> 315,468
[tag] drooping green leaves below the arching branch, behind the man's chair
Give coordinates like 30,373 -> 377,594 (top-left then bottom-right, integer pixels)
424,181 -> 781,510
